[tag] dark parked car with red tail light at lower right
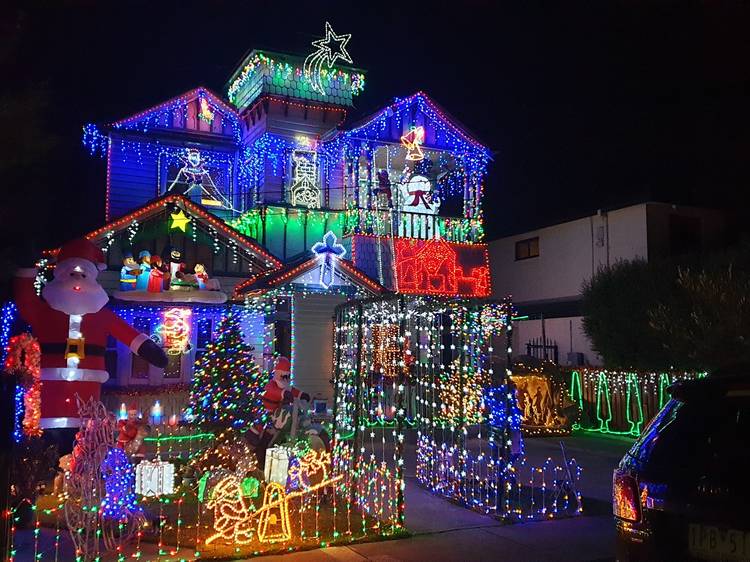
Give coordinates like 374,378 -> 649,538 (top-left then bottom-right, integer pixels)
612,369 -> 750,562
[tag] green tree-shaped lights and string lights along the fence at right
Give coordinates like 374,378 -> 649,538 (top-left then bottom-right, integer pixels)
567,368 -> 706,437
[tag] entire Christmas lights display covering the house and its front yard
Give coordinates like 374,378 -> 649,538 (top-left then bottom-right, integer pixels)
0,27 -> 568,561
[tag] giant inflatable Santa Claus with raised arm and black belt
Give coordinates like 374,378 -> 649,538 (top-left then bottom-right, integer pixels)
14,239 -> 167,429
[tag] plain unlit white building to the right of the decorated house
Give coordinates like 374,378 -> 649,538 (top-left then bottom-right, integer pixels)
489,203 -> 725,365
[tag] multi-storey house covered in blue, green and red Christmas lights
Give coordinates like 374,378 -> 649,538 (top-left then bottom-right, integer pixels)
48,47 -> 490,416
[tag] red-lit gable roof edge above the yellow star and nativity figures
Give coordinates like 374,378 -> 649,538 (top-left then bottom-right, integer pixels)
44,194 -> 282,271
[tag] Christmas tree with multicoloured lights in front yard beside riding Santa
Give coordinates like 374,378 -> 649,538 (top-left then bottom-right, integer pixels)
190,313 -> 267,429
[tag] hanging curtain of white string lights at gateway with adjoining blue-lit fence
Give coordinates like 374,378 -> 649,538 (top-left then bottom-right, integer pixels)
333,296 -> 582,525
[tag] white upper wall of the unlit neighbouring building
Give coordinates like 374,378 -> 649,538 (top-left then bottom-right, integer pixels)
489,204 -> 648,303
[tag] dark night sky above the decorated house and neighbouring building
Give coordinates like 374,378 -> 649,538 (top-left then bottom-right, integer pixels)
0,0 -> 750,253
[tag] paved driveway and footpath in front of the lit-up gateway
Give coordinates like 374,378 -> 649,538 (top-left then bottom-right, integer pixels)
264,433 -> 632,562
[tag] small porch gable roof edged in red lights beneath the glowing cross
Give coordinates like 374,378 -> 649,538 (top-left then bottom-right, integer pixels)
234,251 -> 387,298
